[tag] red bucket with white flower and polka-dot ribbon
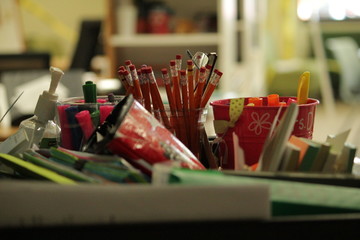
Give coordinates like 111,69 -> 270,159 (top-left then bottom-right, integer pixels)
210,97 -> 319,169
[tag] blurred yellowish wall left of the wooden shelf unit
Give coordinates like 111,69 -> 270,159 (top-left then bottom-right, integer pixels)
17,0 -> 106,68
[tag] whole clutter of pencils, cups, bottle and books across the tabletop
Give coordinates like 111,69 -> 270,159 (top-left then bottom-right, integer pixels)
0,53 -> 356,186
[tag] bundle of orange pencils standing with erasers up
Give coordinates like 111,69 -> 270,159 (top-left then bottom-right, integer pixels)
118,54 -> 223,157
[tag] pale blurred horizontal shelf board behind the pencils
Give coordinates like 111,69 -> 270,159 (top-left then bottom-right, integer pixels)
110,33 -> 219,47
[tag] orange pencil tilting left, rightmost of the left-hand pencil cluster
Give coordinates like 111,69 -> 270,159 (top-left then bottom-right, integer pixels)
146,66 -> 172,131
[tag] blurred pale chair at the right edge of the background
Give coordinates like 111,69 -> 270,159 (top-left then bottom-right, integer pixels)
326,37 -> 360,103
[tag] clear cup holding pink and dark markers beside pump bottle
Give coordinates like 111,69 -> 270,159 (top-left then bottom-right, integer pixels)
55,95 -> 124,150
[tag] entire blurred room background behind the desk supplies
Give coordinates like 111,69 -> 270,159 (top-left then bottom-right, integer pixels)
0,0 -> 360,152
